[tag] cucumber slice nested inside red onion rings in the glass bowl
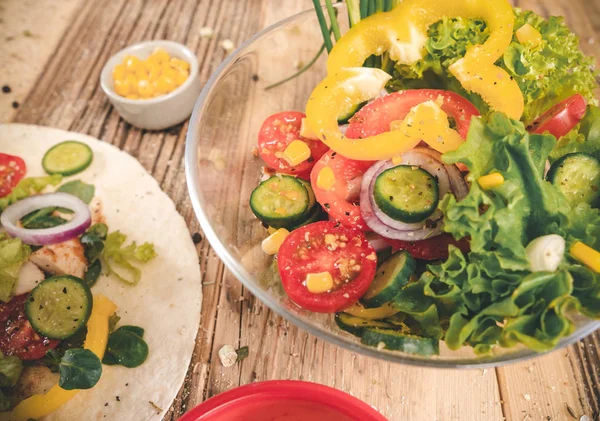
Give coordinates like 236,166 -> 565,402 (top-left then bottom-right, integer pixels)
373,165 -> 439,223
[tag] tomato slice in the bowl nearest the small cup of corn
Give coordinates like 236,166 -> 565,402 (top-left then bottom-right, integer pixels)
258,111 -> 329,179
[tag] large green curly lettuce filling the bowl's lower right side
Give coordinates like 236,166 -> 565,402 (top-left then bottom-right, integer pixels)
395,113 -> 600,353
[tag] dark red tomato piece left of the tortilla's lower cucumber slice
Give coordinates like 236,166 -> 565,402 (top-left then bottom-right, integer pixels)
0,294 -> 60,360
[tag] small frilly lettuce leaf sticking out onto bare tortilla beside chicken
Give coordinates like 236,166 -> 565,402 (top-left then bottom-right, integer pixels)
102,231 -> 156,285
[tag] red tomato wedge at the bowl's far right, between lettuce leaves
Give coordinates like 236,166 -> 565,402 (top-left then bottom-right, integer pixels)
527,94 -> 585,139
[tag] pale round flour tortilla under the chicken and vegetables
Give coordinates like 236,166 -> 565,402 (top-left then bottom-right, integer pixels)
0,124 -> 202,421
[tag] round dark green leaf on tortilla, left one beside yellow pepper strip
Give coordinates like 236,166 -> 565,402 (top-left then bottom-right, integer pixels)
58,349 -> 102,390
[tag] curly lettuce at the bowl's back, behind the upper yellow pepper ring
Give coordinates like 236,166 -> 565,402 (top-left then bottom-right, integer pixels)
389,9 -> 596,122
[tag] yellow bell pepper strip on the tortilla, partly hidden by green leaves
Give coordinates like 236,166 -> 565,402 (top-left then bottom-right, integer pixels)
6,295 -> 117,421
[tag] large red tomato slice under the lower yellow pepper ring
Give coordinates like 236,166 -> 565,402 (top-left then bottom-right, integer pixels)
346,89 -> 479,139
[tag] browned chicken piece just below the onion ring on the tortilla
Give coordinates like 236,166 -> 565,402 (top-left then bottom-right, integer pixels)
29,238 -> 87,278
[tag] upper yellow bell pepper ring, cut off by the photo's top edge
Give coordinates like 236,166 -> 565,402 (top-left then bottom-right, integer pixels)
322,0 -> 524,120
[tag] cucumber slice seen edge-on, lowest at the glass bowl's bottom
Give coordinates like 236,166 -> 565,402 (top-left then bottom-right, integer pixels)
361,327 -> 440,356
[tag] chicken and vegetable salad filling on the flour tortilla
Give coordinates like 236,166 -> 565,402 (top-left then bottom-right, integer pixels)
0,141 -> 156,420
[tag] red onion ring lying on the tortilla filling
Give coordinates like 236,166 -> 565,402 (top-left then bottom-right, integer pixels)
0,193 -> 92,246
